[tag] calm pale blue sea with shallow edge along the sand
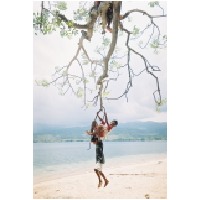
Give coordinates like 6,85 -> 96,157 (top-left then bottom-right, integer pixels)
33,140 -> 167,182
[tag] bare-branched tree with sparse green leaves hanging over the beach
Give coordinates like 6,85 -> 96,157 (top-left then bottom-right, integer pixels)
33,1 -> 167,111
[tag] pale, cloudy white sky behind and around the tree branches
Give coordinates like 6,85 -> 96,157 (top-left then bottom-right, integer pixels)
33,2 -> 167,127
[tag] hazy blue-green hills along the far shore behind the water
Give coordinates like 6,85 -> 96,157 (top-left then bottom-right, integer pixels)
33,122 -> 167,143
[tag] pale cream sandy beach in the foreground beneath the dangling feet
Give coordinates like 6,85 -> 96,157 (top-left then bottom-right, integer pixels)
33,155 -> 167,199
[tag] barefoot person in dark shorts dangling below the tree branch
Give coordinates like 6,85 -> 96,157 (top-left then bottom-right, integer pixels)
86,112 -> 118,187
